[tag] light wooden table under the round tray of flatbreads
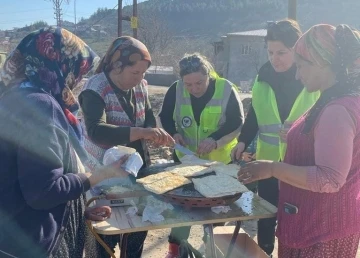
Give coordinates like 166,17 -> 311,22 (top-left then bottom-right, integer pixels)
88,192 -> 277,257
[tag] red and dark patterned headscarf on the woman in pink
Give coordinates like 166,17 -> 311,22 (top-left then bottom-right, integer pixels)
294,24 -> 360,134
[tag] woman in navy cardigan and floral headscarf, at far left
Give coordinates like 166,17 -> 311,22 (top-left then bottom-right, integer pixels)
0,27 -> 126,258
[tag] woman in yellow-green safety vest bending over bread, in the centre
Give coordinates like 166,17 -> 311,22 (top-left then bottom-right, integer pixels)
159,53 -> 244,258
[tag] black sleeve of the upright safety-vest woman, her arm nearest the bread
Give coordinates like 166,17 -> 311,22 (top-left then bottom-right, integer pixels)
238,104 -> 259,149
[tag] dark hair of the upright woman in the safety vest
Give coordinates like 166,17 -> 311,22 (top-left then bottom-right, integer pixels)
265,19 -> 302,48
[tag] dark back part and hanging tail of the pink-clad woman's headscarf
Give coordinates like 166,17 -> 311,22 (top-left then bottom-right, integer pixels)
303,25 -> 360,134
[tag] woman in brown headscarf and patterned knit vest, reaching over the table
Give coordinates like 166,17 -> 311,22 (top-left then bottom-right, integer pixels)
79,36 -> 174,258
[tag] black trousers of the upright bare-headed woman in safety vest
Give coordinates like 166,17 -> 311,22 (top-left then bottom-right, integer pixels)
257,178 -> 279,255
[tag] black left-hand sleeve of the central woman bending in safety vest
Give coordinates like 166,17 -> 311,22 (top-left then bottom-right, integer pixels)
159,82 -> 177,135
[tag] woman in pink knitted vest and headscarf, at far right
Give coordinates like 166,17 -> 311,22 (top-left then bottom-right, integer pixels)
239,24 -> 360,258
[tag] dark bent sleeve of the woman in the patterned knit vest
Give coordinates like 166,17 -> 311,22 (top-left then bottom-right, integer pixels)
79,90 -> 131,146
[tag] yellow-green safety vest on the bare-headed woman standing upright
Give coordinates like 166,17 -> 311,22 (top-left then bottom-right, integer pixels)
252,78 -> 320,161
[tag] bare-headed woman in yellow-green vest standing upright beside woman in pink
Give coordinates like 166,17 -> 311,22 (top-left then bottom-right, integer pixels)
232,20 -> 319,255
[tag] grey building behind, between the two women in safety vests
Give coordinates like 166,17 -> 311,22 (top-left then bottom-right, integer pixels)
213,29 -> 267,91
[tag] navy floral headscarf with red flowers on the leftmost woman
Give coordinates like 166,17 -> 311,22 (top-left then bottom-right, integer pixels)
0,27 -> 99,138
